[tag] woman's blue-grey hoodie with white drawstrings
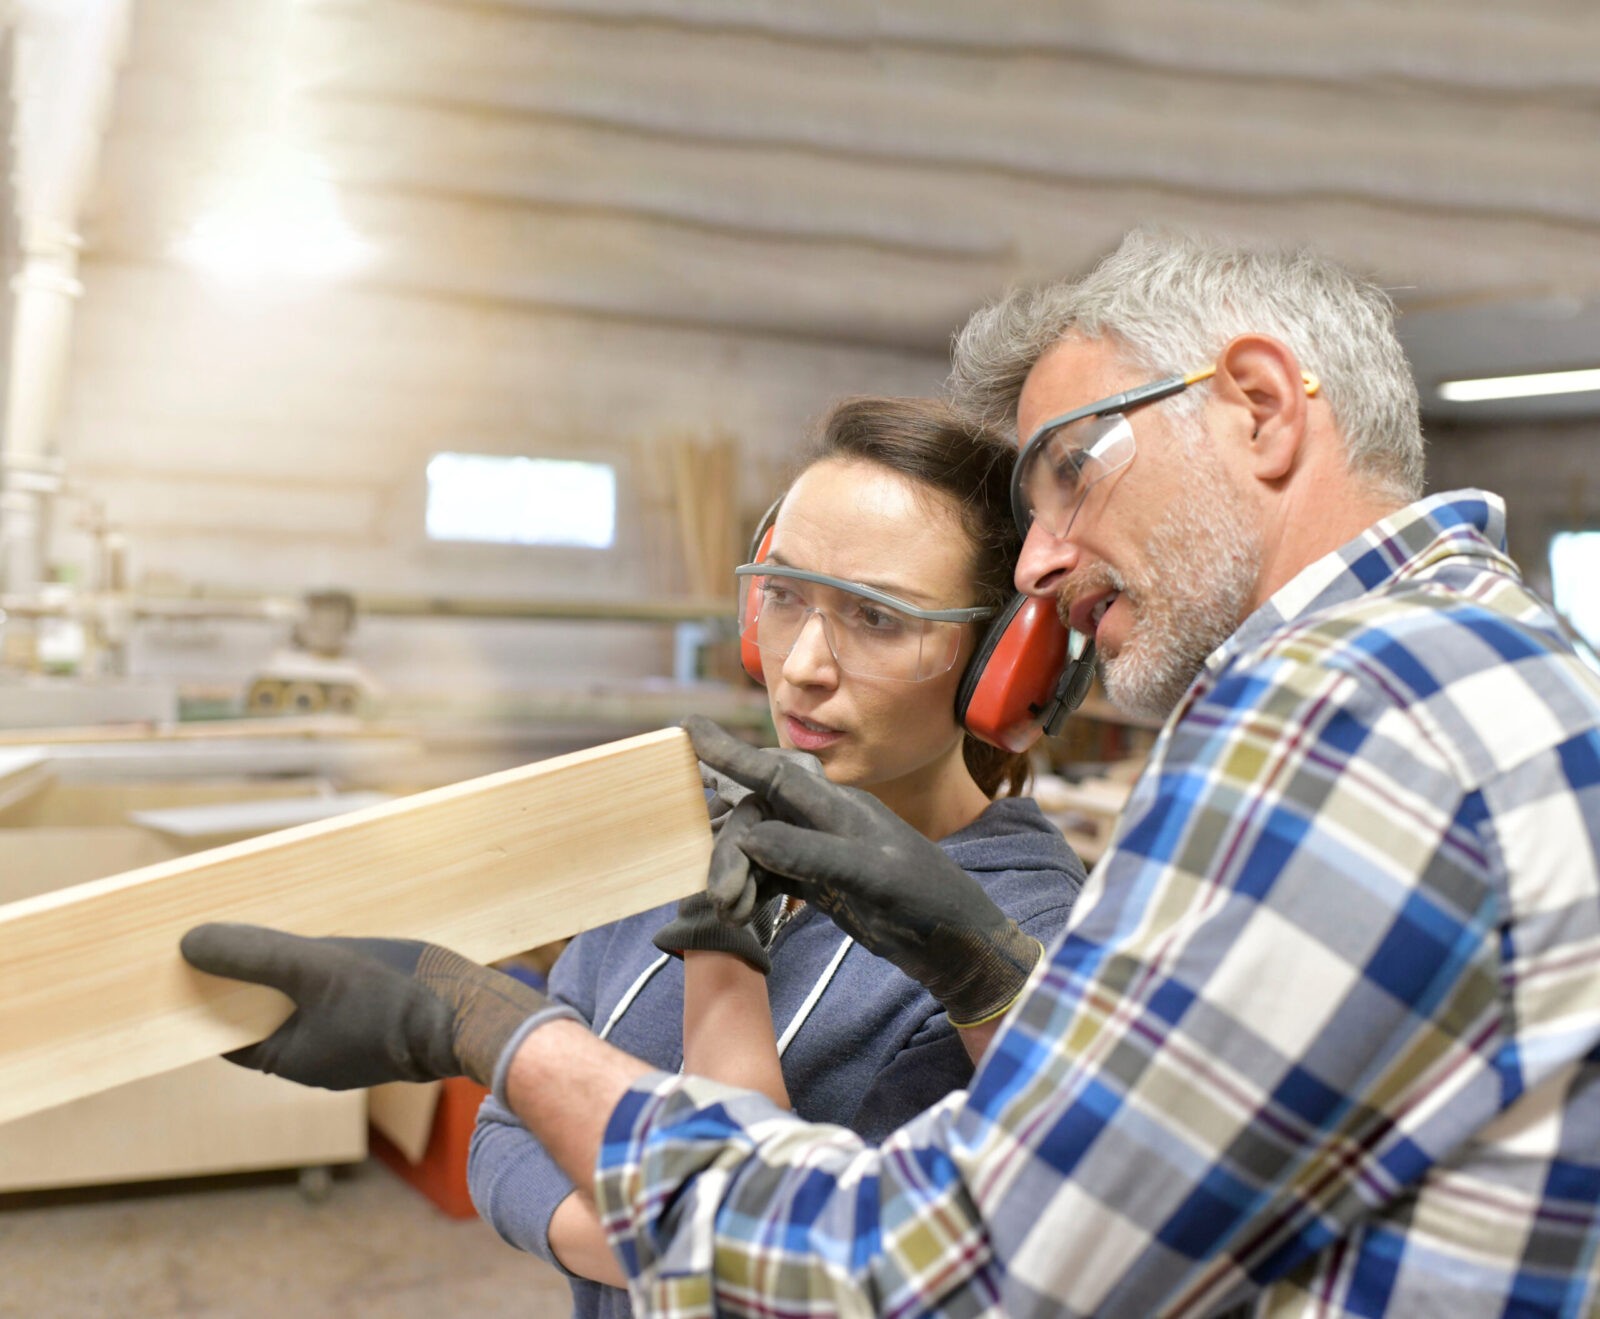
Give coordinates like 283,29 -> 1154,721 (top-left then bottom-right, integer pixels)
467,797 -> 1085,1319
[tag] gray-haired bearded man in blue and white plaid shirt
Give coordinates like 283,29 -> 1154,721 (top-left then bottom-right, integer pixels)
181,235 -> 1600,1319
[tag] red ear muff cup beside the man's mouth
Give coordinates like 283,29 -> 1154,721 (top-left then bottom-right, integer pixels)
955,595 -> 1094,751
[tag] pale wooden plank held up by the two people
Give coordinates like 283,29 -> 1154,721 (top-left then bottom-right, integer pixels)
0,728 -> 710,1122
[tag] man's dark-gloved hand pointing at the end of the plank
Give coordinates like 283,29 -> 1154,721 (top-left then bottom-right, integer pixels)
683,716 -> 1043,1026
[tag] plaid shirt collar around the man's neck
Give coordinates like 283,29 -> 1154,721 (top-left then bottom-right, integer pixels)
1206,490 -> 1520,674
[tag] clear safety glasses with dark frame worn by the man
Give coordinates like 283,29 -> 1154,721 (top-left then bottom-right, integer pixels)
1011,365 -> 1318,541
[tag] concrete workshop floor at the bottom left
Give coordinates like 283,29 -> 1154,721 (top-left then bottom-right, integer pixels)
0,1159 -> 570,1319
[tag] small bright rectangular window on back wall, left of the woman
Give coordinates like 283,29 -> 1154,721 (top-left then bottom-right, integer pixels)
427,453 -> 616,549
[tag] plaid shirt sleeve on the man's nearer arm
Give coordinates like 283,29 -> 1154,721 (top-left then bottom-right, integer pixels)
598,658 -> 1504,1316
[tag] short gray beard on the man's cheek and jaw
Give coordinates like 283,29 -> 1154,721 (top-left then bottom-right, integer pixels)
1098,437 -> 1261,719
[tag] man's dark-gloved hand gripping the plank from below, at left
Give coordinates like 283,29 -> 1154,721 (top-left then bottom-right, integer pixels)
179,924 -> 576,1090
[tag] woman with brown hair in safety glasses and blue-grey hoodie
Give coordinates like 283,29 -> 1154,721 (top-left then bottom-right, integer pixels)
469,399 -> 1083,1316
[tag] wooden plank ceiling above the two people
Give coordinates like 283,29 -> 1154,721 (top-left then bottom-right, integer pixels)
86,0 -> 1600,352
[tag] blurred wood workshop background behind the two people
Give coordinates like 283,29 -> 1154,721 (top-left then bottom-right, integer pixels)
0,0 -> 1600,1316
